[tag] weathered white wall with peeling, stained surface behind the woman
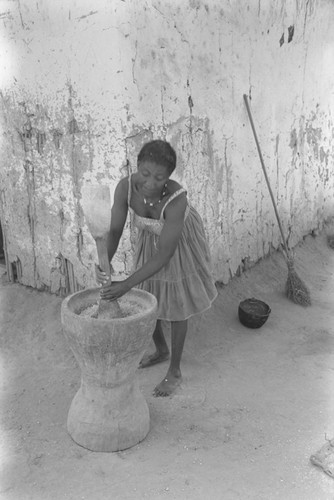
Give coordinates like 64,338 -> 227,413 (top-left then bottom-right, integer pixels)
0,0 -> 334,293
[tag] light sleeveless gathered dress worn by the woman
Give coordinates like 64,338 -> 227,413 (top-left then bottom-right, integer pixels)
128,178 -> 217,321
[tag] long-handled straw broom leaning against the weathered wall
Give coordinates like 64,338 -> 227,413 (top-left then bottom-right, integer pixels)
244,94 -> 311,306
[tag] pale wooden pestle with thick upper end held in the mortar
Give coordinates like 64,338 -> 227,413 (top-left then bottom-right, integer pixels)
81,184 -> 122,319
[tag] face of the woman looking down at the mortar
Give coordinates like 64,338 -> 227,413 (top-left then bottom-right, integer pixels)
138,161 -> 169,198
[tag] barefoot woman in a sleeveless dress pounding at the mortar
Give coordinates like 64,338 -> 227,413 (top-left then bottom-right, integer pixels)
96,140 -> 217,396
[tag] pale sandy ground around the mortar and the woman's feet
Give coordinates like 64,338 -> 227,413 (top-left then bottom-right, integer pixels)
0,230 -> 334,500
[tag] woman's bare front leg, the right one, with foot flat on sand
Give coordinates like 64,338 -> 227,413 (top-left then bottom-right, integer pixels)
153,320 -> 188,396
